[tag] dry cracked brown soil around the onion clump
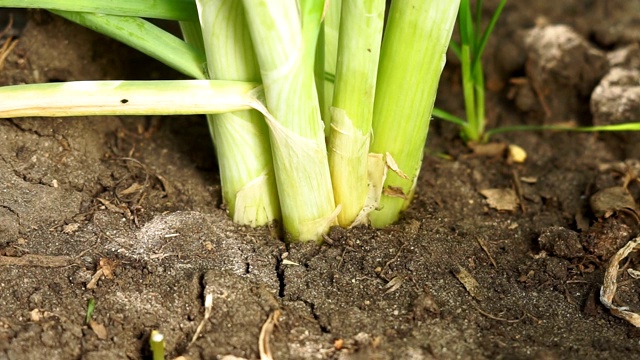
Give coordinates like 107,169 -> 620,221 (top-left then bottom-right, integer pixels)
0,0 -> 640,360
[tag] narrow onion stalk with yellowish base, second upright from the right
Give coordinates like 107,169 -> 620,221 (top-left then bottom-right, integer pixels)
328,0 -> 385,227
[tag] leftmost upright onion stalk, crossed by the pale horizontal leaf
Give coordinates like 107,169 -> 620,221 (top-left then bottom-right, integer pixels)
195,0 -> 280,226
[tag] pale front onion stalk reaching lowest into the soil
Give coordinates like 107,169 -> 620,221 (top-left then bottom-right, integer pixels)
243,0 -> 340,241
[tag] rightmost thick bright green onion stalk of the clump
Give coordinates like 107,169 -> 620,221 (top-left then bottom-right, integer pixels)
370,0 -> 459,227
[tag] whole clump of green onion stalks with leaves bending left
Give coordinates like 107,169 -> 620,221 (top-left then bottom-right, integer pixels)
0,0 -> 460,241
